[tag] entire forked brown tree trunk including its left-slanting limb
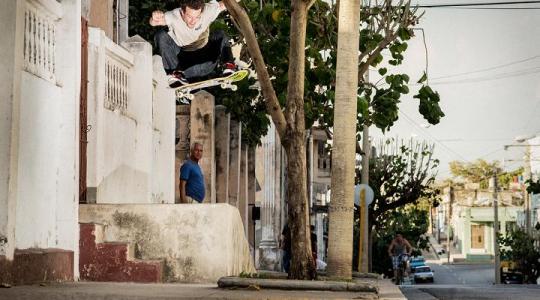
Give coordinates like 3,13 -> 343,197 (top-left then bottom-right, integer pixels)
223,0 -> 316,279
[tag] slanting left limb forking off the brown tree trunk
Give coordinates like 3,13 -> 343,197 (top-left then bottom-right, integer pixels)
223,0 -> 287,139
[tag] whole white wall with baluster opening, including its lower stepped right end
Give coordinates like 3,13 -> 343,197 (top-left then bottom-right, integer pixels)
87,28 -> 175,203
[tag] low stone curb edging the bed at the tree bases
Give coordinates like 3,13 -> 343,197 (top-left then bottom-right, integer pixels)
218,277 -> 379,293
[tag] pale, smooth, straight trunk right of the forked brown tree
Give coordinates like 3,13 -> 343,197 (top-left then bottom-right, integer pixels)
327,0 -> 360,279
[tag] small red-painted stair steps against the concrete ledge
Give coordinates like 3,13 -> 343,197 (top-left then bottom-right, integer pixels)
79,223 -> 163,283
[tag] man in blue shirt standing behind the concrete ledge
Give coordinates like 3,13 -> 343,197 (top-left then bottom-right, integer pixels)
180,142 -> 205,203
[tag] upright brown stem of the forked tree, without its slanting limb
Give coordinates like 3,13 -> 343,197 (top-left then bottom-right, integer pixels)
283,0 -> 316,279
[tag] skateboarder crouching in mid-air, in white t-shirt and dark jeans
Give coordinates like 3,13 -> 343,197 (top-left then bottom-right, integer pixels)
150,0 -> 237,88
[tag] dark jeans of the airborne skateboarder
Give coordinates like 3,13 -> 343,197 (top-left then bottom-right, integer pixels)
154,30 -> 234,80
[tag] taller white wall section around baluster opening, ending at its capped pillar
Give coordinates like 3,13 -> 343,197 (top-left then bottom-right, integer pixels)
87,28 -> 152,203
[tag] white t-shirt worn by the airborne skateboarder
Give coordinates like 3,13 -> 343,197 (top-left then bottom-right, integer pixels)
165,0 -> 223,51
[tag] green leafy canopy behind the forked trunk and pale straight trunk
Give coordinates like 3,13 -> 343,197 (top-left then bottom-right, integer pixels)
129,0 -> 444,144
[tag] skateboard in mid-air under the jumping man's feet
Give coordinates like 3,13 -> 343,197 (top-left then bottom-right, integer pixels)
175,70 -> 249,102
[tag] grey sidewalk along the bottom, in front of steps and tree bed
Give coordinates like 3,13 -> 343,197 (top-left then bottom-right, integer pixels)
0,279 -> 406,300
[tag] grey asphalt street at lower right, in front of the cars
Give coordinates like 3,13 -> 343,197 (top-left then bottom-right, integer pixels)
401,263 -> 540,300
